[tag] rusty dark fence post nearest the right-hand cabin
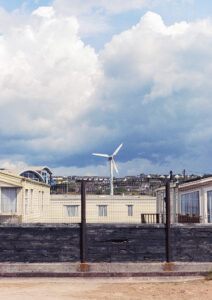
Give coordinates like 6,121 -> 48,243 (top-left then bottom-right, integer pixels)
166,181 -> 171,263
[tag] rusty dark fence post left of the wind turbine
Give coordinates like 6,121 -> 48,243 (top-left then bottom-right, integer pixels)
81,181 -> 86,263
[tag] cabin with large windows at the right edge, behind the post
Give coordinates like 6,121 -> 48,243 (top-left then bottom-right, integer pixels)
156,176 -> 212,224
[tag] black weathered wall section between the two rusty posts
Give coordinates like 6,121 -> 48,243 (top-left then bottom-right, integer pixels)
87,224 -> 166,262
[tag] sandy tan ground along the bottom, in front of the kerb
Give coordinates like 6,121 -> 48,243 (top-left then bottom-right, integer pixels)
0,278 -> 212,300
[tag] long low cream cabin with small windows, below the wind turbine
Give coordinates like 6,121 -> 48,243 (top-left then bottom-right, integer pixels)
49,194 -> 156,223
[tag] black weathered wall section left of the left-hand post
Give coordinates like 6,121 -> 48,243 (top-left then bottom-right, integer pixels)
0,224 -> 80,262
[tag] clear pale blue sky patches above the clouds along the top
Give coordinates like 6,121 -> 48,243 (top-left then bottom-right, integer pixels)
0,0 -> 212,50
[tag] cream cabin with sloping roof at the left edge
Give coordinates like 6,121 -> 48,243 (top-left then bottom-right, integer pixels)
0,171 -> 50,222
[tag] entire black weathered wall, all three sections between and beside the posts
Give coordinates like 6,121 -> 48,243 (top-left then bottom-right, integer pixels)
0,224 -> 212,263
